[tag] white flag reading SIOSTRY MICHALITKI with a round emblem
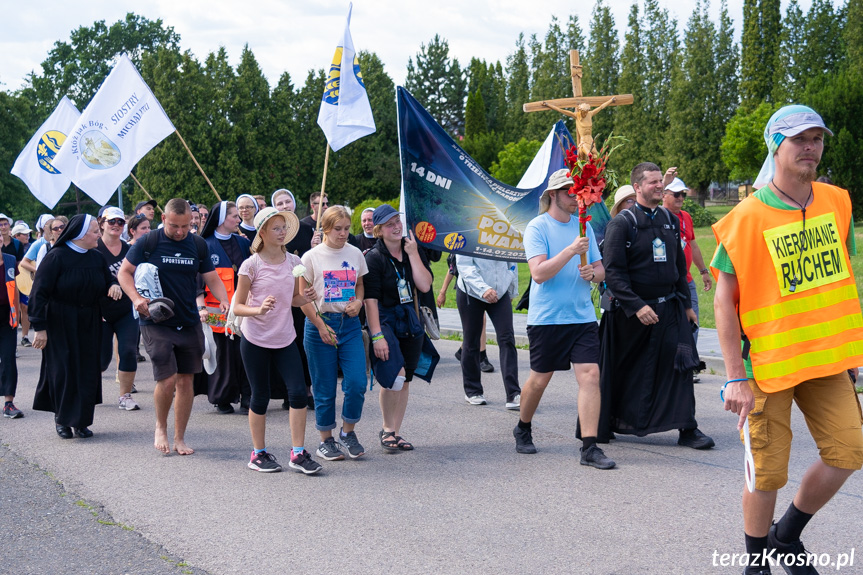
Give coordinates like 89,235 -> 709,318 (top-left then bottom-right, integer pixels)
54,54 -> 175,205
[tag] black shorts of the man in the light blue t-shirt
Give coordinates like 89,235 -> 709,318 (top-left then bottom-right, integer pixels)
527,321 -> 599,373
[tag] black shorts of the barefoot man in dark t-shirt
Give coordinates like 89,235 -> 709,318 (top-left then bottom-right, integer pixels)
141,323 -> 204,381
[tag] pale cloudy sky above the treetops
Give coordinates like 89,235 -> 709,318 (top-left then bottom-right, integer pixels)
0,0 -> 820,90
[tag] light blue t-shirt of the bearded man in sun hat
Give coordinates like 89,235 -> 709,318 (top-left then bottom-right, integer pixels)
524,213 -> 601,325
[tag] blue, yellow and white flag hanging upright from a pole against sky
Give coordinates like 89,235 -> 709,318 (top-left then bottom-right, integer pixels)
318,4 -> 375,152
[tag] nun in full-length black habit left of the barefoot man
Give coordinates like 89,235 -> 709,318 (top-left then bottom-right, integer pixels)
29,215 -> 122,439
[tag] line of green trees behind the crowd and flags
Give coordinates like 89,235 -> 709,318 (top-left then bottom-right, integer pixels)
0,0 -> 863,224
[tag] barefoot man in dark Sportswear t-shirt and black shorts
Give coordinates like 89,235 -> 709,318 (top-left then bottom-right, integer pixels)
117,198 -> 229,455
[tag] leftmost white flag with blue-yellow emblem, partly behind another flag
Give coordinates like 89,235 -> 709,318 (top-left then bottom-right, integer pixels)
12,96 -> 81,209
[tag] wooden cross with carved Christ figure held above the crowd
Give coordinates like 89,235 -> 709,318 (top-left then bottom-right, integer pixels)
522,50 -> 634,160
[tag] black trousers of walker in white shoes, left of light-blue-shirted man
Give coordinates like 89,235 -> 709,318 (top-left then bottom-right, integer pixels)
455,288 -> 521,401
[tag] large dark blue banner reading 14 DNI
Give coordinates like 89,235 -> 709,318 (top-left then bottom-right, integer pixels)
397,86 -> 610,261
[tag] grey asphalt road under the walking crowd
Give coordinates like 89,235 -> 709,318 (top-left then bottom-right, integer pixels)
0,341 -> 863,575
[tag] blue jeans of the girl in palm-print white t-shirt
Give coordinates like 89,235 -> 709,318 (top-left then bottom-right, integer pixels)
304,313 -> 366,431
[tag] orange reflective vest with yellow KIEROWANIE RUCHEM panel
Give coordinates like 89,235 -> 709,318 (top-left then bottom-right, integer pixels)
713,182 -> 863,393
